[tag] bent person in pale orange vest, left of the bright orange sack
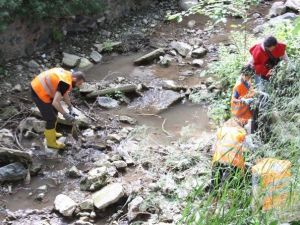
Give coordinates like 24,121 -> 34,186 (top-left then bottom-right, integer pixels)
210,125 -> 246,192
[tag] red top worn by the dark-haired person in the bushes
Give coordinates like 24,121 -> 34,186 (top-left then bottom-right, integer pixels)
250,43 -> 286,80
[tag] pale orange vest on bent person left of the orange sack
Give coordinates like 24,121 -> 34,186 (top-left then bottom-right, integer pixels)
212,127 -> 247,169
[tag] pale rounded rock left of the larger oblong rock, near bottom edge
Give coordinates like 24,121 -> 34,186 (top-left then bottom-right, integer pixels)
54,194 -> 77,217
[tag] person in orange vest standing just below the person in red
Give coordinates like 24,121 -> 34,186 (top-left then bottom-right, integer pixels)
231,65 -> 255,125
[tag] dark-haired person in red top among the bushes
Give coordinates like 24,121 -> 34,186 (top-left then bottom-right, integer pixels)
250,36 -> 288,91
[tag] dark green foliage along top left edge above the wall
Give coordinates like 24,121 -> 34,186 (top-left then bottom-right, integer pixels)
0,0 -> 104,31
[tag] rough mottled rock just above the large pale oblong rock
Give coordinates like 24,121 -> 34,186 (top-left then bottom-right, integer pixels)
80,166 -> 108,191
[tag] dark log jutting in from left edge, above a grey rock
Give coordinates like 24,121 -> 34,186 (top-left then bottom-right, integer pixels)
0,147 -> 32,165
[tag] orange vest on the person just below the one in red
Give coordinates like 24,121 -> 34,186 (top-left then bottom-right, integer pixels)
231,81 -> 254,123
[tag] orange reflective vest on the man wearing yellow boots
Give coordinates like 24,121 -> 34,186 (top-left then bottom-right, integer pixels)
31,68 -> 72,103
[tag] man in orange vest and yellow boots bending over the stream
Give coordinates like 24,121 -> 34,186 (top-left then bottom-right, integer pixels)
31,68 -> 85,149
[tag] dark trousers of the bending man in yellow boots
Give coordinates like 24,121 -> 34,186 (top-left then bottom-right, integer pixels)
31,89 -> 58,129
